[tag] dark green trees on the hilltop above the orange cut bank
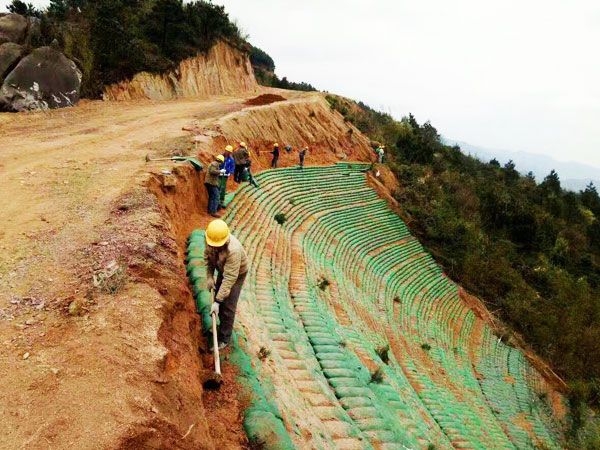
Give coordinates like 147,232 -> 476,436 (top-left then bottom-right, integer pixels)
9,0 -> 249,97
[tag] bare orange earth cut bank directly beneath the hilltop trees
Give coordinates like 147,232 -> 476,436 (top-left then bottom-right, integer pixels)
104,42 -> 258,100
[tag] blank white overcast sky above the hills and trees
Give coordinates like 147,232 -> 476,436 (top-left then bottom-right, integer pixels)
0,0 -> 600,167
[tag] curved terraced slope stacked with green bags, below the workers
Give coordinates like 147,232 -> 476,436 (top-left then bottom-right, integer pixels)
193,163 -> 561,449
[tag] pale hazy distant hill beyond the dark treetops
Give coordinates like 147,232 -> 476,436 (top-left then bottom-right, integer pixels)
444,138 -> 600,191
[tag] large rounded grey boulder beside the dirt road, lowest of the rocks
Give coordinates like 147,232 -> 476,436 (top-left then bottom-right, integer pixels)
0,47 -> 81,111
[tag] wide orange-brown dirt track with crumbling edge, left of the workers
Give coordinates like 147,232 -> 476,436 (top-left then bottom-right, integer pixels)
0,97 -> 255,448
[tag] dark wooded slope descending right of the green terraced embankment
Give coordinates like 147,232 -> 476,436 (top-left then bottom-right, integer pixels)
327,95 -> 600,436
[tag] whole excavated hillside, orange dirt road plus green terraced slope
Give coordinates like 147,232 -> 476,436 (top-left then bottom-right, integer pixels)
0,16 -> 580,449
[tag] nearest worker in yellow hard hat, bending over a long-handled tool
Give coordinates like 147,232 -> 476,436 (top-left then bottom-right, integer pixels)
204,219 -> 248,350
